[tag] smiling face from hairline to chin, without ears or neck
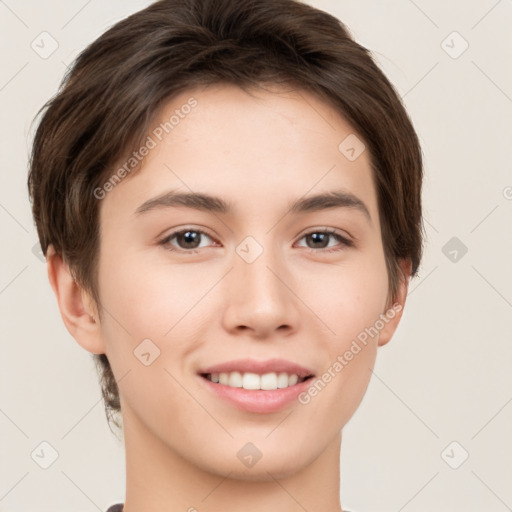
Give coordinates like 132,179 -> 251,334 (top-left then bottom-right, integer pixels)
84,85 -> 406,479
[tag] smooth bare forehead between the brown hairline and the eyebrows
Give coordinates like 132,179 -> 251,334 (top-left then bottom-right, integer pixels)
102,84 -> 377,226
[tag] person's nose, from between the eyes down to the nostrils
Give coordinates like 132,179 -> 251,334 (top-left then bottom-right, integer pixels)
223,243 -> 301,339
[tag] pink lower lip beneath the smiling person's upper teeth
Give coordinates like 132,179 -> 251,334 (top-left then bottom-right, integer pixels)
199,375 -> 313,414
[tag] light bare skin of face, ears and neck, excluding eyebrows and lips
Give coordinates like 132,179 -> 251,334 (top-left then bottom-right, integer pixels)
48,85 -> 410,512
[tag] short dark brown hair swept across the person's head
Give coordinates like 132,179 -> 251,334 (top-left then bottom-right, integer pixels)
28,0 -> 423,432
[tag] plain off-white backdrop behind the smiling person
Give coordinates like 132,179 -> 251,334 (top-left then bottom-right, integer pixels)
0,0 -> 512,512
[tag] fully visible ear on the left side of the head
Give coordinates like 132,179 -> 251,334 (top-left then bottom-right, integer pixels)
46,245 -> 106,354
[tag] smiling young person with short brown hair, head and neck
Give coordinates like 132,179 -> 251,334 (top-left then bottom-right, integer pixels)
28,0 -> 423,512
